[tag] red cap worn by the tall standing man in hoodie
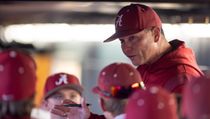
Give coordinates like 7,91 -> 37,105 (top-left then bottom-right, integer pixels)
104,4 -> 162,42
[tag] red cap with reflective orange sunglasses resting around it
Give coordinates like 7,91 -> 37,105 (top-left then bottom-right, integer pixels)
93,63 -> 144,98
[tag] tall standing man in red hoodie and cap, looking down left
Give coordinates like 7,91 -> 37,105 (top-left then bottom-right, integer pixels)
104,4 -> 203,93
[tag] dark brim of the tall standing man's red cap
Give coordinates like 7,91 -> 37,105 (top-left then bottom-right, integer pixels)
104,29 -> 141,42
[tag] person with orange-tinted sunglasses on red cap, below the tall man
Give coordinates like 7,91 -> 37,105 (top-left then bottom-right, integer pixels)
93,63 -> 145,119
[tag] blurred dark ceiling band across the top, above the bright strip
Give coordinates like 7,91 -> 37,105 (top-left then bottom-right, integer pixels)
0,0 -> 210,25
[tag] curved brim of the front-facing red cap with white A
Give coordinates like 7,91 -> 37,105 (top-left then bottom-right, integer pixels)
44,84 -> 83,99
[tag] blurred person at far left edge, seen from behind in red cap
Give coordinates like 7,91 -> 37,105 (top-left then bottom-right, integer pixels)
0,49 -> 37,119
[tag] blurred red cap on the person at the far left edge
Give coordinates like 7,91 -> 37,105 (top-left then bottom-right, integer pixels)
0,49 -> 37,101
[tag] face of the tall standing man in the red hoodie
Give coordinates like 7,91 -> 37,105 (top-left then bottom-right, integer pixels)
119,29 -> 157,66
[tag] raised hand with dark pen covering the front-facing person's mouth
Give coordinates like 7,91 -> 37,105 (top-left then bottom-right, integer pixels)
51,99 -> 90,119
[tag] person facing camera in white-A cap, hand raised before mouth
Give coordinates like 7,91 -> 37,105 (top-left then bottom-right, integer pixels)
42,73 -> 104,119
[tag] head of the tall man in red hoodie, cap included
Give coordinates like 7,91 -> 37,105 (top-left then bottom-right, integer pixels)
104,4 -> 164,66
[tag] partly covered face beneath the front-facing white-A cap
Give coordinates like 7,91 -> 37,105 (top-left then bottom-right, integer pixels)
47,88 -> 81,105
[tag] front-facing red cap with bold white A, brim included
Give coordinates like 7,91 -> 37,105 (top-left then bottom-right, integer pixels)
44,73 -> 83,99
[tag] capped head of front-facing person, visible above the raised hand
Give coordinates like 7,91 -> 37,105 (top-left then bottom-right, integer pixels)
44,73 -> 83,103
